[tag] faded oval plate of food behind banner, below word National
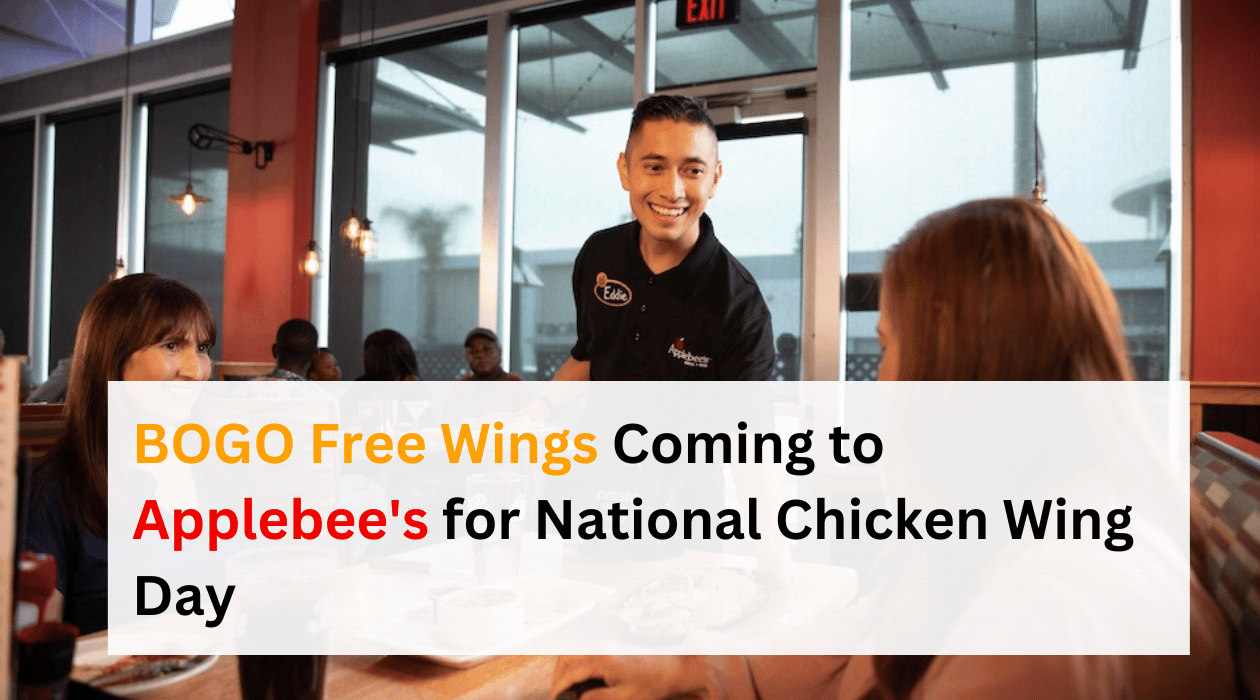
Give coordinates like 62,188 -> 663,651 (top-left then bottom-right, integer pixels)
616,567 -> 769,643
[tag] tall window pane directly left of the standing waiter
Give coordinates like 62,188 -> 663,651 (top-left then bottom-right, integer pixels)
512,6 -> 635,379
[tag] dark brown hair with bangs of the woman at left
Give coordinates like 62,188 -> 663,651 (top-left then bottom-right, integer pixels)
45,273 -> 215,536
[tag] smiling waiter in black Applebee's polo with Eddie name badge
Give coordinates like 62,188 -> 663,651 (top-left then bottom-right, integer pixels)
553,94 -> 775,380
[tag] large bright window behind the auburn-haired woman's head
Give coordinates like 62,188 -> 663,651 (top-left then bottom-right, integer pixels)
845,0 -> 1177,379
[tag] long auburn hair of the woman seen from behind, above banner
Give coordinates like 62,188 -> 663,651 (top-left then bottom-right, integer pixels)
881,199 -> 1133,381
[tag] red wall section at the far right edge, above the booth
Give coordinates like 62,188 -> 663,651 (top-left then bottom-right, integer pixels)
1189,0 -> 1260,381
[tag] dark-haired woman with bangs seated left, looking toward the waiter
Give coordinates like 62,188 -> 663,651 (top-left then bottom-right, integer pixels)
23,273 -> 215,635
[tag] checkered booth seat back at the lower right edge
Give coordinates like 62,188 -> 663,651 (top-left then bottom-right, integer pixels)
1189,433 -> 1260,699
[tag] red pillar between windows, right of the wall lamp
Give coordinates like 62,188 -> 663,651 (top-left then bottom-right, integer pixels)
221,0 -> 319,361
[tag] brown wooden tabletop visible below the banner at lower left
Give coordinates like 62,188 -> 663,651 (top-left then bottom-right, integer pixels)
72,632 -> 556,700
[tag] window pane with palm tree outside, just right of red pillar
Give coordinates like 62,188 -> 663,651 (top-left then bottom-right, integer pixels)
330,26 -> 486,380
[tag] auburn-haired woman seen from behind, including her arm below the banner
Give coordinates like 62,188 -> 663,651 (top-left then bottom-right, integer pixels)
554,199 -> 1235,700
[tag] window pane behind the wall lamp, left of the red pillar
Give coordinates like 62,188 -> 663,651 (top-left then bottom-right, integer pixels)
145,84 -> 228,356
